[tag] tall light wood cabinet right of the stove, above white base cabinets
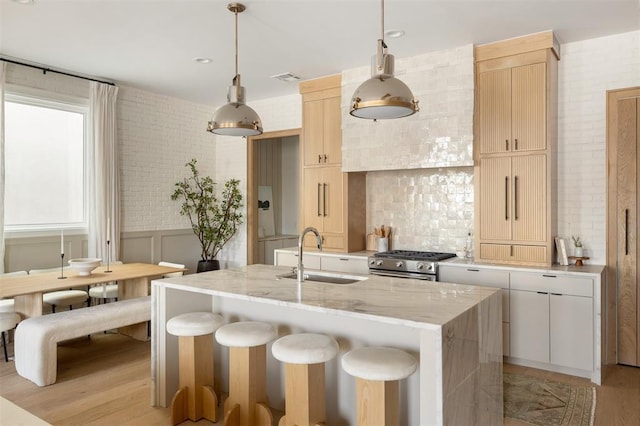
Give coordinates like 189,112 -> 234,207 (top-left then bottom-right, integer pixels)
474,32 -> 559,266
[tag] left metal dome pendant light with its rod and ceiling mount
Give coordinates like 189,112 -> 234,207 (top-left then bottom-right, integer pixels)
207,3 -> 262,136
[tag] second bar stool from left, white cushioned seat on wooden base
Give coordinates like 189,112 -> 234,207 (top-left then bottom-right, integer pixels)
216,321 -> 278,426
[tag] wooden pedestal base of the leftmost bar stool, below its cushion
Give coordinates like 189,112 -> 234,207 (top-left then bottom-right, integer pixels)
172,334 -> 217,422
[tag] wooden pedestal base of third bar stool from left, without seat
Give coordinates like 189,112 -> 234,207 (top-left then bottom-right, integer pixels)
279,363 -> 326,426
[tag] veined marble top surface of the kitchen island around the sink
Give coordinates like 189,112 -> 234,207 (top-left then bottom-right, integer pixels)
152,265 -> 500,329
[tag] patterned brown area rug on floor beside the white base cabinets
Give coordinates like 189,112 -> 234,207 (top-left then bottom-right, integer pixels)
503,373 -> 596,426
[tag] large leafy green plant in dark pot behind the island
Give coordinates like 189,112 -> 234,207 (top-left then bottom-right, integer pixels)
171,159 -> 243,272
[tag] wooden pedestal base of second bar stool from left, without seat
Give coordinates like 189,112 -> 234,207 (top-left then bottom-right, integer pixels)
224,345 -> 273,426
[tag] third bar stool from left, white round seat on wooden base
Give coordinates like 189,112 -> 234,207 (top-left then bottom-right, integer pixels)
271,333 -> 338,426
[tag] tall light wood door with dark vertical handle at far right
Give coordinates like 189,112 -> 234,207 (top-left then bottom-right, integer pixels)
606,87 -> 640,366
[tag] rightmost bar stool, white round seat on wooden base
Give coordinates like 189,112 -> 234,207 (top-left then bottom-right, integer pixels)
342,346 -> 418,426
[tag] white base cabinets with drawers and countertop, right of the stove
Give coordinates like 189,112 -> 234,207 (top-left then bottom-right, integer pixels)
439,259 -> 606,384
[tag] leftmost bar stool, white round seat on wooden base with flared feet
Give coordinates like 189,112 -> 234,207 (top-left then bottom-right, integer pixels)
167,312 -> 224,425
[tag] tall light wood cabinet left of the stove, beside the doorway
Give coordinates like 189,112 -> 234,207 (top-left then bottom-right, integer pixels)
300,75 -> 366,252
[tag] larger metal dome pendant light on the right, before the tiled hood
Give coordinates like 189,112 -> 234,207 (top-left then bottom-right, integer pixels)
349,0 -> 420,121
